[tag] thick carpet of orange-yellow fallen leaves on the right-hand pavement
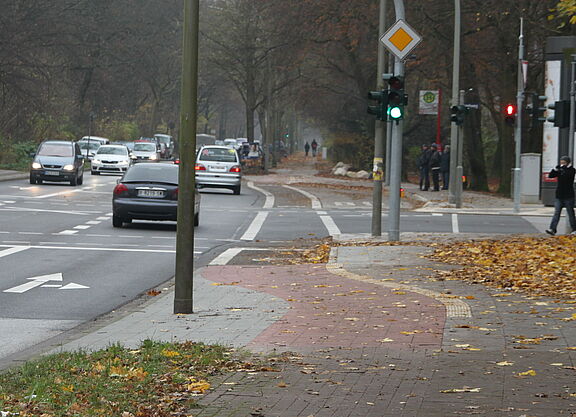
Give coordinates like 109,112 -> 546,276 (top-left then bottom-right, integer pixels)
431,236 -> 576,299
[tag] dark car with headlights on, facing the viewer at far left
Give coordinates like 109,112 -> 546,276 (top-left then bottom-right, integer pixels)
30,140 -> 84,185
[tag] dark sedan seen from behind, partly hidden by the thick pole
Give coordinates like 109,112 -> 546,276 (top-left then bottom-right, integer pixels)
112,163 -> 200,227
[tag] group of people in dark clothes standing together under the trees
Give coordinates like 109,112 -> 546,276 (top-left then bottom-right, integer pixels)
417,143 -> 450,191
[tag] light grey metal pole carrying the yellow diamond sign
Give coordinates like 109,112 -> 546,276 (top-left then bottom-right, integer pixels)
388,0 -> 405,242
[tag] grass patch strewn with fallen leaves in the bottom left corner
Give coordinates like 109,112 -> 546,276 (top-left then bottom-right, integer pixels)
0,340 -> 266,417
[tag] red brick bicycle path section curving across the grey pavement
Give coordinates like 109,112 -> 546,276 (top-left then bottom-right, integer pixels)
202,264 -> 446,351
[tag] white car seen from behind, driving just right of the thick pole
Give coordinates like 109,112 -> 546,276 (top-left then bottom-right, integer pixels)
195,146 -> 242,195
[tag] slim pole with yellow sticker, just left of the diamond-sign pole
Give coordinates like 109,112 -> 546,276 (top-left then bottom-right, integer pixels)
372,0 -> 388,236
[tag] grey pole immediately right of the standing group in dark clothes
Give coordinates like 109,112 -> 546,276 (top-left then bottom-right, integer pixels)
448,0 -> 462,207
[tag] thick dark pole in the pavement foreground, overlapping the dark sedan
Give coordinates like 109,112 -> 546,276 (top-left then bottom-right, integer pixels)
174,0 -> 200,314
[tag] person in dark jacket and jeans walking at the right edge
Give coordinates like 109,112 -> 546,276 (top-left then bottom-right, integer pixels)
546,156 -> 576,236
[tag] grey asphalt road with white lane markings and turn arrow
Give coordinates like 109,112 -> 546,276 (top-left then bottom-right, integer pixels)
0,175 -> 547,358
